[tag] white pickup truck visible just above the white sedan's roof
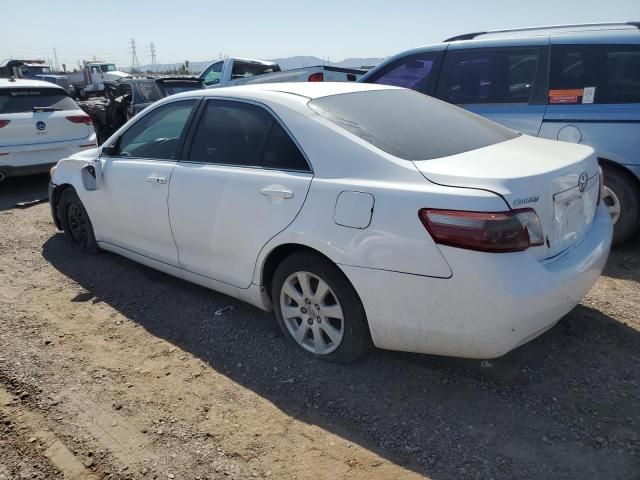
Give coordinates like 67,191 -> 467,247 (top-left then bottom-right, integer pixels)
200,58 -> 365,88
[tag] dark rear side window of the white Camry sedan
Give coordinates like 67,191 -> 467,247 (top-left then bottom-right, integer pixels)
188,100 -> 309,171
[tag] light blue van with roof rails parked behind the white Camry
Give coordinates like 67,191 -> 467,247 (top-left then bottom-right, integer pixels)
359,22 -> 640,245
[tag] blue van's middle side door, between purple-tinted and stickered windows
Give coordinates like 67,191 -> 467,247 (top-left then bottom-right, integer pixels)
438,44 -> 548,135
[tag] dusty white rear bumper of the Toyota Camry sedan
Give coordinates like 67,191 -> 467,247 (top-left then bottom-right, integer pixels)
341,205 -> 612,358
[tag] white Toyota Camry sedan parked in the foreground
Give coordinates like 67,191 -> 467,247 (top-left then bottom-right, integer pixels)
50,83 -> 612,363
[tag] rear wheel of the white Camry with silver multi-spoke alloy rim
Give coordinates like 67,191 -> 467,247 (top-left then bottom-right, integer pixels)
271,252 -> 372,364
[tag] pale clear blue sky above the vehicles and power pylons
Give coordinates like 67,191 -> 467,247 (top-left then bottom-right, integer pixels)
0,0 -> 640,68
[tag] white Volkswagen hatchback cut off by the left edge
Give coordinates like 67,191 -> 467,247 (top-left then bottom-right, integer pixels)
0,79 -> 97,180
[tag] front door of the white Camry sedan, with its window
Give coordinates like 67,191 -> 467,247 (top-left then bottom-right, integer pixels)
89,99 -> 199,266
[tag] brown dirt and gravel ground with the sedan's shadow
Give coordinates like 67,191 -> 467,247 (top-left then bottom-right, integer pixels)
0,177 -> 640,480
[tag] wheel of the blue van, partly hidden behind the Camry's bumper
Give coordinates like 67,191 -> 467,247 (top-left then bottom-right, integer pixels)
602,167 -> 640,246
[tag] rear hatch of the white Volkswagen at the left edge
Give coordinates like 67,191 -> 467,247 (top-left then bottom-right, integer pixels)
0,87 -> 92,147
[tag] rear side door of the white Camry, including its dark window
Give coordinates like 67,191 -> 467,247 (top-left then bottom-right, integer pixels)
169,99 -> 313,288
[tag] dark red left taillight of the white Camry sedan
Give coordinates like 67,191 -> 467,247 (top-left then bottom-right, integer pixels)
418,208 -> 544,252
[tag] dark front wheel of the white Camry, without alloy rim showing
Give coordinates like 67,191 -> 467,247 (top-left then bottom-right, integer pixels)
56,188 -> 100,253
